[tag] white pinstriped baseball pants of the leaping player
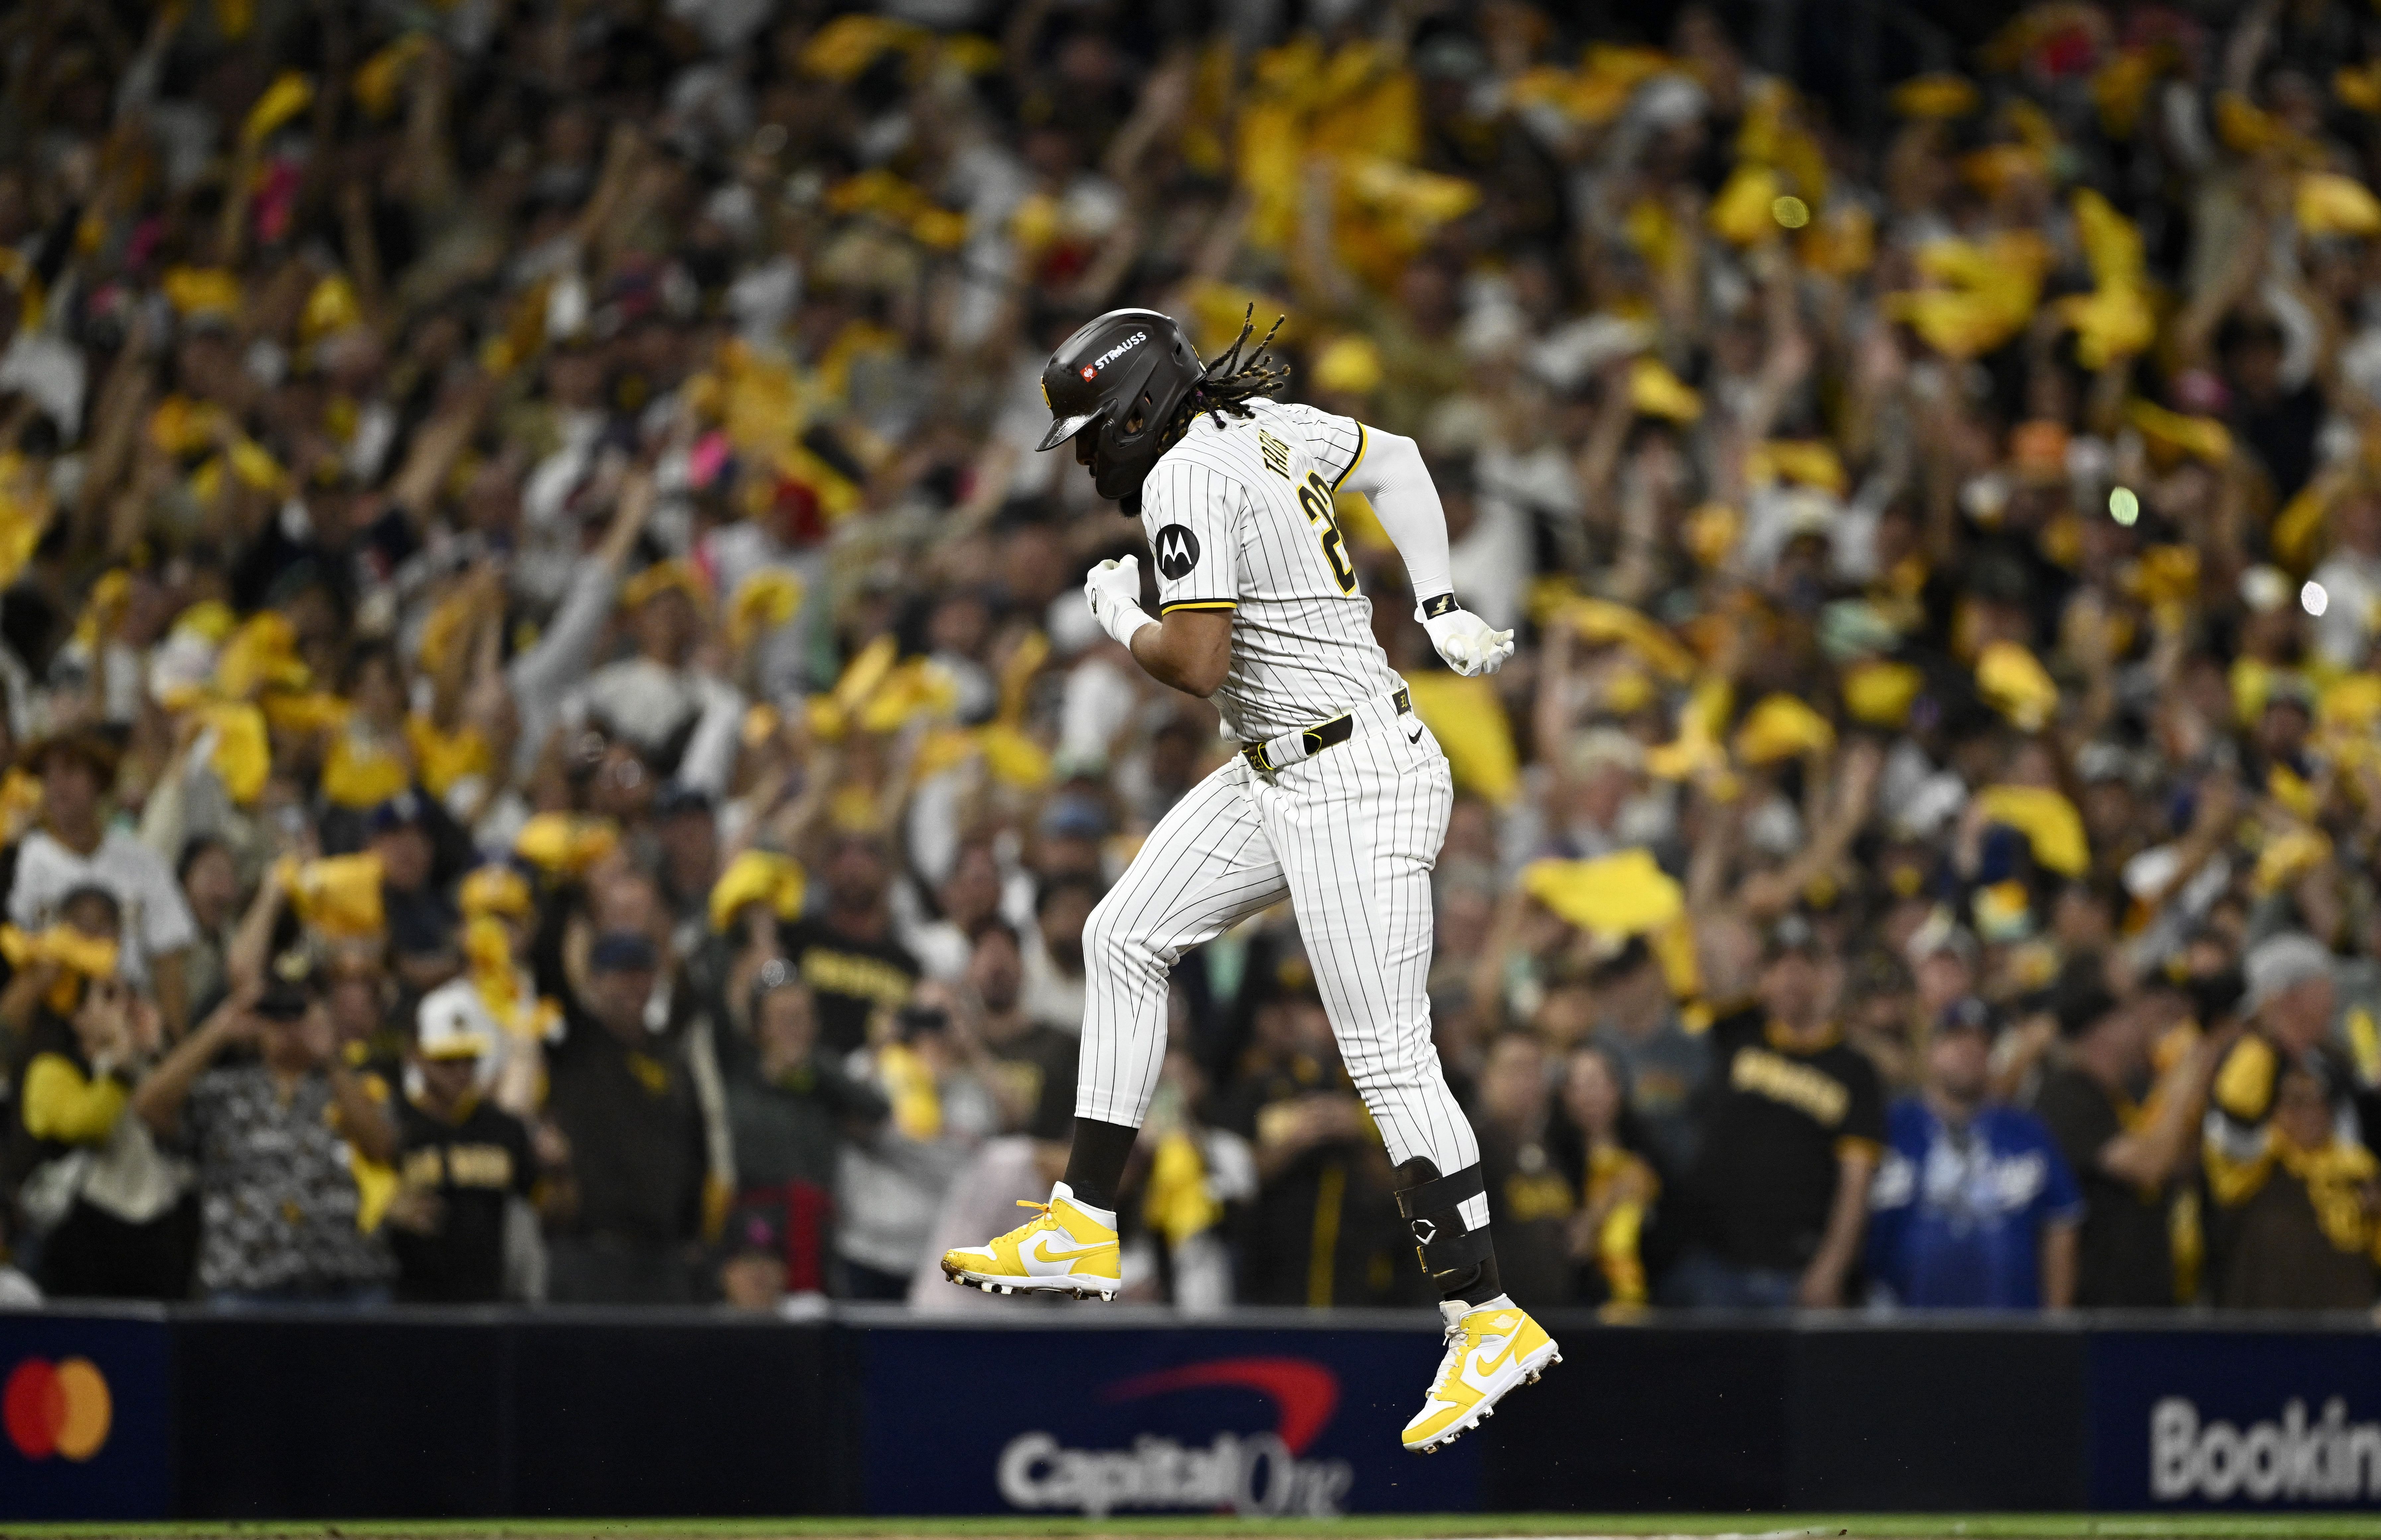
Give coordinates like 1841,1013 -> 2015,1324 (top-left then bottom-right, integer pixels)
1074,702 -> 1488,1204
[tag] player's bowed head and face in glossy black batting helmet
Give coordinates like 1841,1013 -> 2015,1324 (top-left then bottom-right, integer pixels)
1041,309 -> 1207,502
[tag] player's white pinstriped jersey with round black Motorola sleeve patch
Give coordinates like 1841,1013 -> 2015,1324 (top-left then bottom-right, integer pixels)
1141,397 -> 1402,743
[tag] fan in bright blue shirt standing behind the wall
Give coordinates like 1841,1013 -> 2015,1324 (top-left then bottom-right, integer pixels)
1869,1000 -> 2083,1309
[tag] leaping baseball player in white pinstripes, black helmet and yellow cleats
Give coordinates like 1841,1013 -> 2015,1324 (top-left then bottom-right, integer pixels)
943,309 -> 1562,1452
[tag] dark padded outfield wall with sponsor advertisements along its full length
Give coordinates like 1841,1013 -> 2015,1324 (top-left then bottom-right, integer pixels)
0,1304 -> 2381,1521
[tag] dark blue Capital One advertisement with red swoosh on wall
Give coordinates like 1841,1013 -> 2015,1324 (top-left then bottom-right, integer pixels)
862,1326 -> 1481,1518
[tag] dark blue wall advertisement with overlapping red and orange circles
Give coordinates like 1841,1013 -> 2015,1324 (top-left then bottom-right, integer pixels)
0,1314 -> 174,1521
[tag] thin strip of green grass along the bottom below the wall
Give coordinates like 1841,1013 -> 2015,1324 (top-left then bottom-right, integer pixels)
0,1514 -> 2381,1540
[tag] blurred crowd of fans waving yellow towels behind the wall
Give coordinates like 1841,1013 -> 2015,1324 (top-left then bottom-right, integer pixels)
0,0 -> 2381,1314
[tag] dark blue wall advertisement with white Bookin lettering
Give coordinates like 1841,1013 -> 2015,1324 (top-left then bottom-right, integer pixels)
2091,1331 -> 2381,1509
